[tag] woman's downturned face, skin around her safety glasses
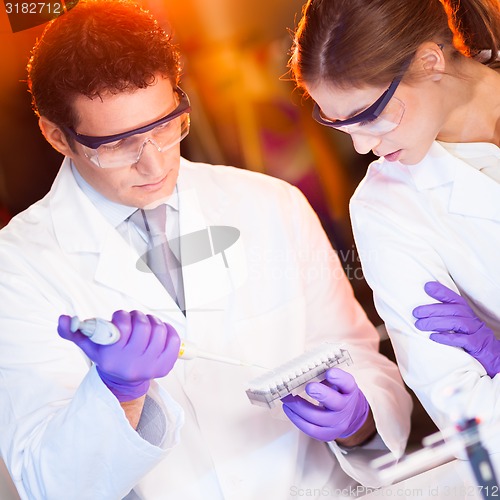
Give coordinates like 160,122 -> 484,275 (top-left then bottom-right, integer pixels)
307,80 -> 444,165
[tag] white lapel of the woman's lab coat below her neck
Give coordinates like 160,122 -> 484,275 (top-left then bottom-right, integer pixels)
409,139 -> 500,221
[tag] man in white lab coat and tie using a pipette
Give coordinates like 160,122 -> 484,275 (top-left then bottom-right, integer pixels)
0,1 -> 411,500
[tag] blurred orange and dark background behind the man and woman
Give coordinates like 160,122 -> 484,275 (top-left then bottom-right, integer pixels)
0,0 -> 435,446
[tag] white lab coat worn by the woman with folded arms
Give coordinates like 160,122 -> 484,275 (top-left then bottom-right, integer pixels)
351,142 -> 500,460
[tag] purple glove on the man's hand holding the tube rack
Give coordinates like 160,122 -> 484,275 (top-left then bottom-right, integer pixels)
282,368 -> 370,441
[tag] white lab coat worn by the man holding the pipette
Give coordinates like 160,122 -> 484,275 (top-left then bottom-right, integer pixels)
0,160 -> 411,500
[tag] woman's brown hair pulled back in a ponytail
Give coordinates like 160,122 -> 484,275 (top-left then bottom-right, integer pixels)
289,0 -> 500,88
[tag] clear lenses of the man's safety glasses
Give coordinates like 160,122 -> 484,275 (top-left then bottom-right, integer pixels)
82,113 -> 190,168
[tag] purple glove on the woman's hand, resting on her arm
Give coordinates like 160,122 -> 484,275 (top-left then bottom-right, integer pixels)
413,281 -> 500,377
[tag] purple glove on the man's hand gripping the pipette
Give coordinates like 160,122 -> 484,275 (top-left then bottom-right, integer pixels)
57,311 -> 180,402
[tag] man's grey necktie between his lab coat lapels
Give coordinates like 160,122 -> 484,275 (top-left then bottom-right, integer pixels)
131,205 -> 185,311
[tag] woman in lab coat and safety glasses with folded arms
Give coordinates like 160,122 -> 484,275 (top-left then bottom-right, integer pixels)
290,0 -> 500,452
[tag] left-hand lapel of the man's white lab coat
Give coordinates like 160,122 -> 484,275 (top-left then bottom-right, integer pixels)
49,159 -> 184,323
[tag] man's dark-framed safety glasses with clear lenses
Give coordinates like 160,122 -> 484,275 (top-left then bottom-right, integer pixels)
63,87 -> 191,168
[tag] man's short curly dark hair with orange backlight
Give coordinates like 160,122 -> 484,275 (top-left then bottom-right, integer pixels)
28,0 -> 180,135
